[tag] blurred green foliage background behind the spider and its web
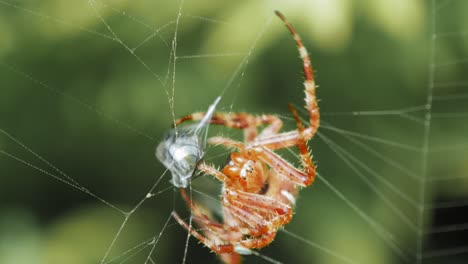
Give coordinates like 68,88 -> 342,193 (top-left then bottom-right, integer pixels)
0,0 -> 468,264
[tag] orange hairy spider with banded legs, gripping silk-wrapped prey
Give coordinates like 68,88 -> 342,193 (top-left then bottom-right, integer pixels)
158,11 -> 320,264
